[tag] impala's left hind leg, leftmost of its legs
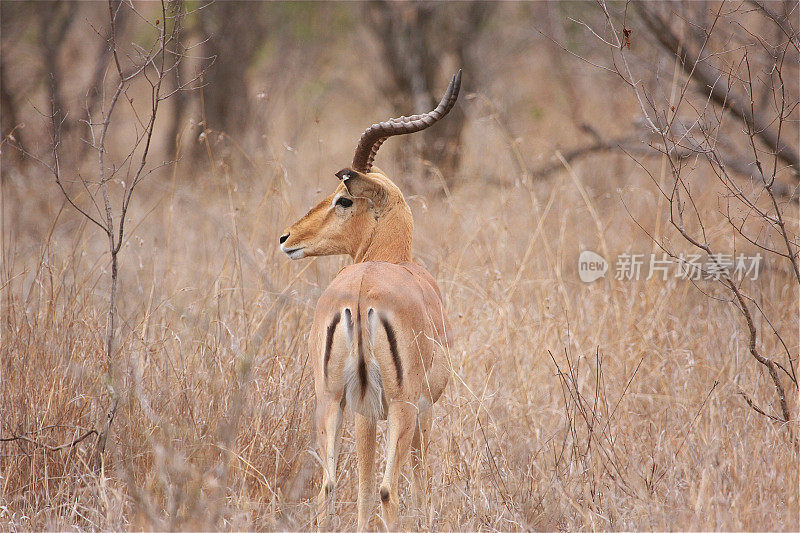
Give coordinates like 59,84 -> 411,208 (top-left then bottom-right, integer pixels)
317,396 -> 344,529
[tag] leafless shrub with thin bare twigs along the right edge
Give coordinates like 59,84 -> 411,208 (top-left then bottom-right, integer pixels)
564,0 -> 800,440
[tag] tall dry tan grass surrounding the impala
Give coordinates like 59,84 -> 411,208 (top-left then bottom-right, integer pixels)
0,3 -> 800,530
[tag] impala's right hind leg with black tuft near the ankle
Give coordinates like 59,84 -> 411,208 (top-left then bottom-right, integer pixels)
380,402 -> 417,531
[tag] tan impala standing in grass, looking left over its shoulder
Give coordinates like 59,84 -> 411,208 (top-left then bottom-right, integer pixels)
280,70 -> 461,530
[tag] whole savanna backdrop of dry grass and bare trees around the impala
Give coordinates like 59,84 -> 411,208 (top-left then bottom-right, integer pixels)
0,0 -> 800,531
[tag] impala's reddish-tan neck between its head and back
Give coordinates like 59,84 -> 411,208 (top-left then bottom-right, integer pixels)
351,200 -> 414,263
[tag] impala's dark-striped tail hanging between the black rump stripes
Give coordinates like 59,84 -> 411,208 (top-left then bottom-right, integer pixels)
343,302 -> 386,421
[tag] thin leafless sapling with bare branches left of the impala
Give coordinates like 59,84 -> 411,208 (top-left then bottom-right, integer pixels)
12,0 -> 205,468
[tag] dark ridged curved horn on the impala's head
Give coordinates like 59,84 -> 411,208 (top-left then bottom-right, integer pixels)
353,69 -> 461,173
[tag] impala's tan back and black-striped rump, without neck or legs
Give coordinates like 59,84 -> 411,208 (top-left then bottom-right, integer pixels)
309,262 -> 449,420
